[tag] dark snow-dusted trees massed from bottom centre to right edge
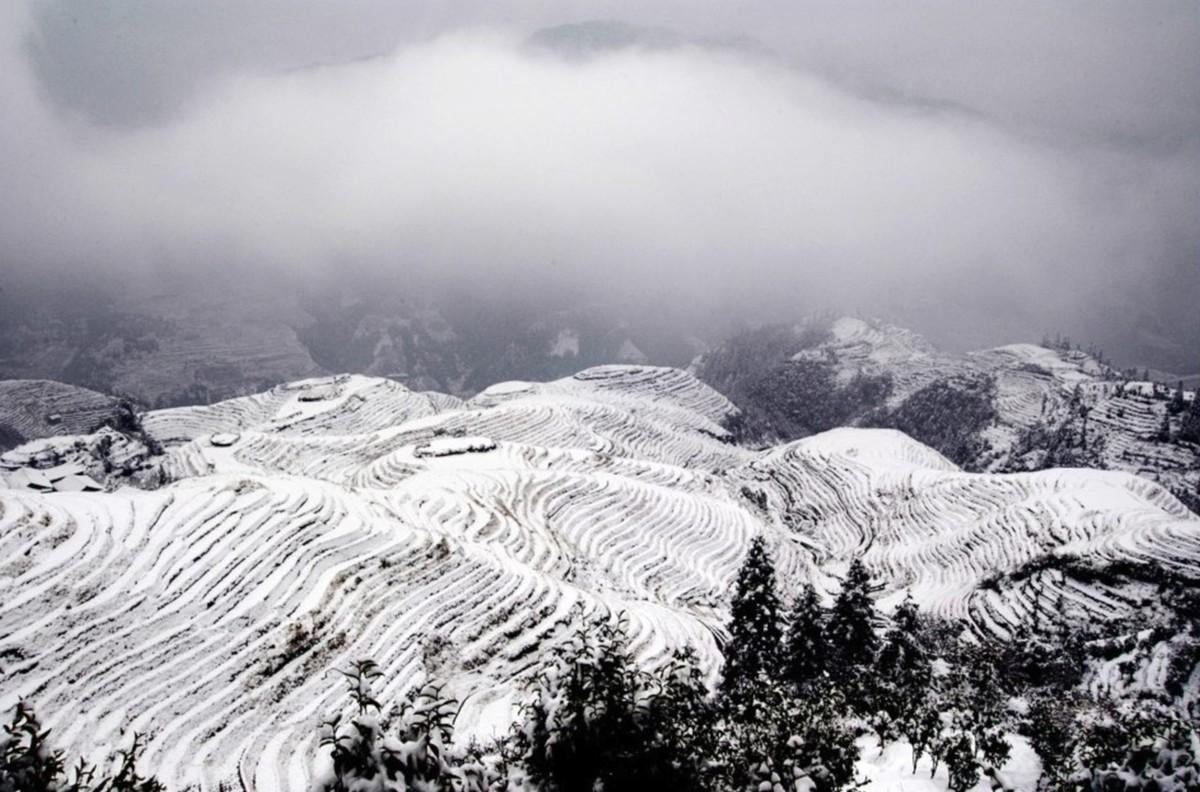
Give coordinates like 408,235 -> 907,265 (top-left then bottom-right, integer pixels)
510,540 -> 1200,792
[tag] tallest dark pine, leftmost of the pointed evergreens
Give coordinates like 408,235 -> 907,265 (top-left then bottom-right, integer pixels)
721,536 -> 782,695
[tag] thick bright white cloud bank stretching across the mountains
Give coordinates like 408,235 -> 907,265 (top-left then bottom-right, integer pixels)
0,3 -> 1200,360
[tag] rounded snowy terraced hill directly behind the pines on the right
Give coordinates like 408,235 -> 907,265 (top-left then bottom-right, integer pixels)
733,428 -> 1200,636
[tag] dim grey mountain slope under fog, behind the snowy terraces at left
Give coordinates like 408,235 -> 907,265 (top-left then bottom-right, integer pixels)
0,283 -> 700,408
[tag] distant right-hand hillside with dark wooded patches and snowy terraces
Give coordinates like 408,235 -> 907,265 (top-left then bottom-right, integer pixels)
692,318 -> 1200,510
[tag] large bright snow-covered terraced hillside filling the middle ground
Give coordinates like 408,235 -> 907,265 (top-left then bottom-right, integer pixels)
0,366 -> 1200,791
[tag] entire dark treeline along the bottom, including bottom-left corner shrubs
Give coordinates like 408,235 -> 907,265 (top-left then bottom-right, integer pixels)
9,539 -> 1200,792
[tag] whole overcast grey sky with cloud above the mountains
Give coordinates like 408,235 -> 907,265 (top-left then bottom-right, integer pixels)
0,0 -> 1200,367
